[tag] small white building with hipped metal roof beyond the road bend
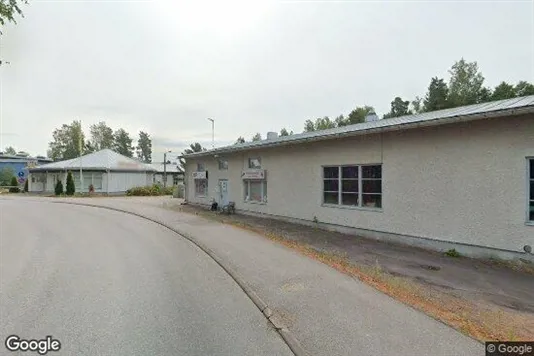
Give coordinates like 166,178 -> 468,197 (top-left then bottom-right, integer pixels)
28,149 -> 156,194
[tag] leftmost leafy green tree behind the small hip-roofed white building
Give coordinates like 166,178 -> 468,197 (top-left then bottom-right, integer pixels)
48,120 -> 85,161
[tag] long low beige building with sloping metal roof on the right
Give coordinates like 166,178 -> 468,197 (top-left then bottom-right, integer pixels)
185,96 -> 534,259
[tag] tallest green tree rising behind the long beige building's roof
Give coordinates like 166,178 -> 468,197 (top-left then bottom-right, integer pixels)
449,58 -> 488,107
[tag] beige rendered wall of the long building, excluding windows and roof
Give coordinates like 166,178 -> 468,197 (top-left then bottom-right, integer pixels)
186,116 -> 534,251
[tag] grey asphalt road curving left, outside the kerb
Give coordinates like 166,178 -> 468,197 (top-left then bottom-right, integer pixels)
0,200 -> 292,356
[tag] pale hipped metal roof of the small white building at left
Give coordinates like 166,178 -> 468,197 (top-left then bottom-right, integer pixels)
30,149 -> 156,172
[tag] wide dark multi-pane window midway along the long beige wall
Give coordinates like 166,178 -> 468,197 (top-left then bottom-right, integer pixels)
323,165 -> 382,208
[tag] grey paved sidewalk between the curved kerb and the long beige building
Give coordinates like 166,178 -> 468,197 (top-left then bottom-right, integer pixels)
18,198 -> 483,356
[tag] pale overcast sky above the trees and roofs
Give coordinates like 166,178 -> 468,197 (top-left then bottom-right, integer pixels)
0,0 -> 534,160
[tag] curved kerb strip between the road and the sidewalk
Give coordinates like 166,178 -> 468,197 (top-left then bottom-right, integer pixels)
50,201 -> 308,356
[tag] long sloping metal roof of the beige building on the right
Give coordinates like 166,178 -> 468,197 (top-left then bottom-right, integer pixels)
183,95 -> 534,158
